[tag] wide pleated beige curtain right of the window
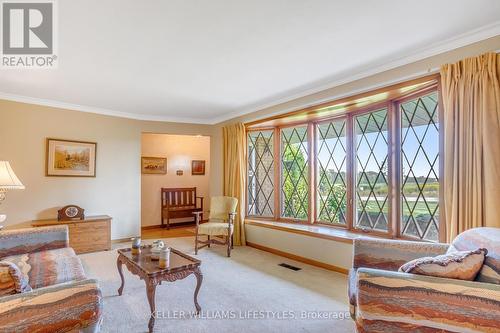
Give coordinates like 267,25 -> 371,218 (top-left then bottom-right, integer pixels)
441,53 -> 500,241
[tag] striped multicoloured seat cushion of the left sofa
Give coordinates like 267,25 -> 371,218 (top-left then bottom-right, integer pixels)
5,247 -> 85,289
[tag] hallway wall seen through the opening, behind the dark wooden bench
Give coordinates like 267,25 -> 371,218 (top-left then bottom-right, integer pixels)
141,133 -> 210,227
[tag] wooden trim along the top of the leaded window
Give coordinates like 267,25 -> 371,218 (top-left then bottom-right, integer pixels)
245,73 -> 439,127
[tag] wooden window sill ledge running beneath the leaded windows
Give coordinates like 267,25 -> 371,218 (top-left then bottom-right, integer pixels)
245,218 -> 381,244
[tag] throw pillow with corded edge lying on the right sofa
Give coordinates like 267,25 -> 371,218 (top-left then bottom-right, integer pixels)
399,249 -> 488,281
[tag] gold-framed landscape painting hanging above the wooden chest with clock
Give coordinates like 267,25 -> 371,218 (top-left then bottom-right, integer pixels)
45,138 -> 97,177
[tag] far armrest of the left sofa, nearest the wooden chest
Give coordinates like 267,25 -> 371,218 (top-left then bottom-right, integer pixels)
0,225 -> 69,258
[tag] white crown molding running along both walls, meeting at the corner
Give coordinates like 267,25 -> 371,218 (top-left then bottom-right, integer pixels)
0,20 -> 500,125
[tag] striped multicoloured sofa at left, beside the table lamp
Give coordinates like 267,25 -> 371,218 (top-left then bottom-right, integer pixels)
0,226 -> 102,333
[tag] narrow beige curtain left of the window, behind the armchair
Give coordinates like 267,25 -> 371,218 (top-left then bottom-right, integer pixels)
222,123 -> 246,245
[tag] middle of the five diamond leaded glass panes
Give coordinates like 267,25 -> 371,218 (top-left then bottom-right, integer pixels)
316,119 -> 347,224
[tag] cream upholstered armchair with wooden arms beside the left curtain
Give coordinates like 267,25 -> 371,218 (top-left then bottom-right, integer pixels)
193,197 -> 238,257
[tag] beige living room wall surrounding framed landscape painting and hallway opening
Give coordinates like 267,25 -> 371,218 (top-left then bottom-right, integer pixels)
0,100 -> 221,239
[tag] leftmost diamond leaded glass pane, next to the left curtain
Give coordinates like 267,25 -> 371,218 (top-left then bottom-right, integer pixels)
247,130 -> 274,216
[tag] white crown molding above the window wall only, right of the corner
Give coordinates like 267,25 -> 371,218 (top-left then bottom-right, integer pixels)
213,21 -> 500,124
